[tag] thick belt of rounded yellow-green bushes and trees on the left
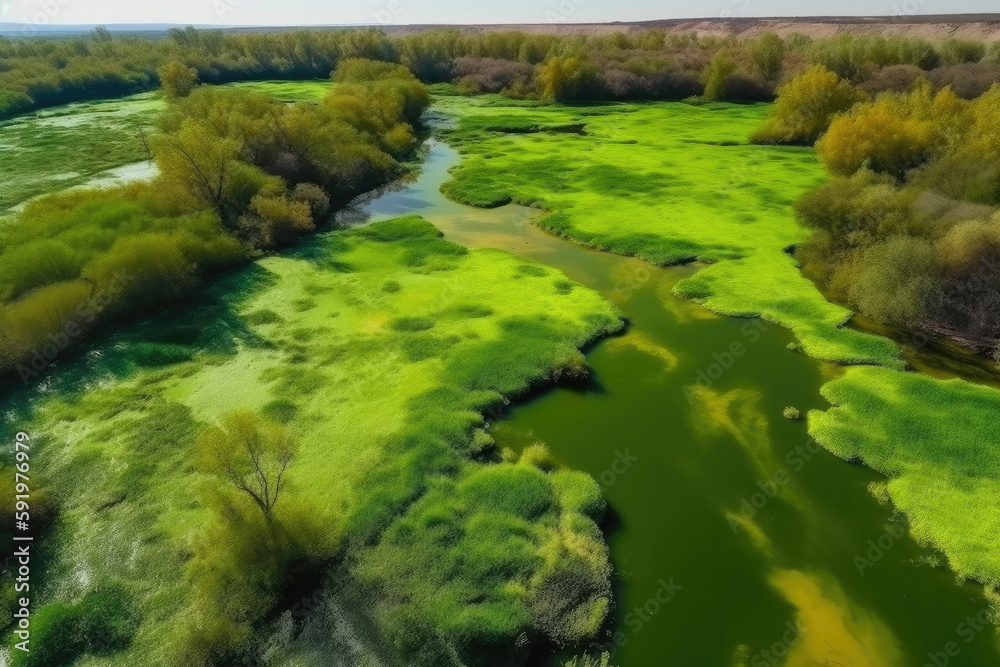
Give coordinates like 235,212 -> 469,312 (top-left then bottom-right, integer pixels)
0,66 -> 428,381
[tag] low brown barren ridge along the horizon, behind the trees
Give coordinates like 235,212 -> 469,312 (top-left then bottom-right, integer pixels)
0,14 -> 1000,41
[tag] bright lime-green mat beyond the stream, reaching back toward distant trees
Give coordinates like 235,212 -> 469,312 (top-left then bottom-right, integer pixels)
440,90 -> 898,364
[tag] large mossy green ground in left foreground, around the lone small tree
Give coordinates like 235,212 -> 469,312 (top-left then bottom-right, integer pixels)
7,217 -> 622,665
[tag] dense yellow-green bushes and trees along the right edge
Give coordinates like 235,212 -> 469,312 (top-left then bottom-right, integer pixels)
755,68 -> 1000,354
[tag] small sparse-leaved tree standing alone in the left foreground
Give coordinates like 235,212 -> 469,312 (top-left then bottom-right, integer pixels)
198,410 -> 296,523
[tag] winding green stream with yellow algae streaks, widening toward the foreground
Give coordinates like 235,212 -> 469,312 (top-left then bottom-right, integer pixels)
348,133 -> 1000,667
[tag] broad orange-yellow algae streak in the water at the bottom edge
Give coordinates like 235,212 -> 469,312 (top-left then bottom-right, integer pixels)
770,570 -> 903,667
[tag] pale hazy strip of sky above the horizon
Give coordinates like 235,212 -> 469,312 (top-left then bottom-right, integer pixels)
0,0 -> 998,25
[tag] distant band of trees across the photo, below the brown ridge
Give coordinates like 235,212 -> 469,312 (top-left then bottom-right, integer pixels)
0,27 -> 1000,118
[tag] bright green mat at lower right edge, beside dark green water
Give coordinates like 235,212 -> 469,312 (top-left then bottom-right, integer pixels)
809,368 -> 1000,587
